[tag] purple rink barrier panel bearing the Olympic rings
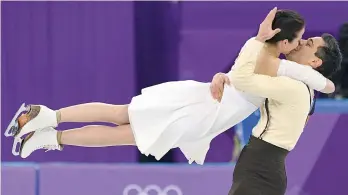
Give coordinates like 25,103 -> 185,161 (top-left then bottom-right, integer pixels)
39,164 -> 233,195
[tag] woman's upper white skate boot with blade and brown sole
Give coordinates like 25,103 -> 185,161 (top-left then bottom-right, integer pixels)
5,103 -> 58,156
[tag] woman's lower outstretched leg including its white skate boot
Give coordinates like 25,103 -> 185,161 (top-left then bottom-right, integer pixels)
20,125 -> 135,158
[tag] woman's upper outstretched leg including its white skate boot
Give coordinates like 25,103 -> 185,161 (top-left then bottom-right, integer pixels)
17,103 -> 129,137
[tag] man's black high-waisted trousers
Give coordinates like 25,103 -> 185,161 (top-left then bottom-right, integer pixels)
228,136 -> 289,195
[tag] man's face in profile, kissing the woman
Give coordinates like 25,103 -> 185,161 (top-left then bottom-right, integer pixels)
286,37 -> 325,68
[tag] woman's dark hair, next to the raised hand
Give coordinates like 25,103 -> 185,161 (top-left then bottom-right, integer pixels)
266,10 -> 305,43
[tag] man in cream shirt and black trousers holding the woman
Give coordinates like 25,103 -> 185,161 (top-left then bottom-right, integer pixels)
213,8 -> 342,195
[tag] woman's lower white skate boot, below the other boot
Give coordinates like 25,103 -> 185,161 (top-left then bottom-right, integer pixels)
19,127 -> 63,158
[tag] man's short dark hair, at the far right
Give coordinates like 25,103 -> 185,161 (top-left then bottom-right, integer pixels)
315,33 -> 342,78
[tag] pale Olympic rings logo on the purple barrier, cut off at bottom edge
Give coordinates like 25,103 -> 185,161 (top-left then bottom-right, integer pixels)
122,184 -> 183,195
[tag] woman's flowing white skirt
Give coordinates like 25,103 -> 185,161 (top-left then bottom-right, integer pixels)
128,80 -> 262,164
